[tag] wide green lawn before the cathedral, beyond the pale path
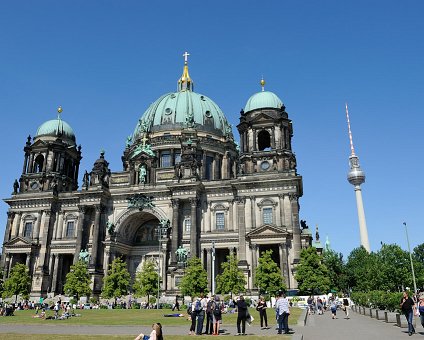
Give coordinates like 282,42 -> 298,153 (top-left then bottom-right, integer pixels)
0,308 -> 301,328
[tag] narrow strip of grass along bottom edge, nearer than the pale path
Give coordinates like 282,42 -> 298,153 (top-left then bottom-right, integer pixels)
0,334 -> 291,340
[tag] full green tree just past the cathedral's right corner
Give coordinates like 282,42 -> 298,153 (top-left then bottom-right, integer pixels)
295,247 -> 330,293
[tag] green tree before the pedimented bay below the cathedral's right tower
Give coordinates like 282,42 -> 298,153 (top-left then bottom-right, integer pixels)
255,250 -> 287,294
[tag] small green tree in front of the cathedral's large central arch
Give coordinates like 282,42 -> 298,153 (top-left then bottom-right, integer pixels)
133,260 -> 159,301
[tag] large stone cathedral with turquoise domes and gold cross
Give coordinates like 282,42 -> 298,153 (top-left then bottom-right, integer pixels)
1,53 -> 312,297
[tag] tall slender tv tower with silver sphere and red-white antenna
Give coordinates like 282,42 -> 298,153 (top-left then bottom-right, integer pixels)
346,103 -> 370,252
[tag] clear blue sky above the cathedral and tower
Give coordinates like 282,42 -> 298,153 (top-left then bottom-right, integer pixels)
0,0 -> 424,255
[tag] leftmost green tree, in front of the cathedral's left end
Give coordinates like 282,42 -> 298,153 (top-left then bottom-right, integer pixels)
3,263 -> 31,303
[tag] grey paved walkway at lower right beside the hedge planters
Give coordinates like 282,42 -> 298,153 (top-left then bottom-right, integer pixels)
295,311 -> 424,340
